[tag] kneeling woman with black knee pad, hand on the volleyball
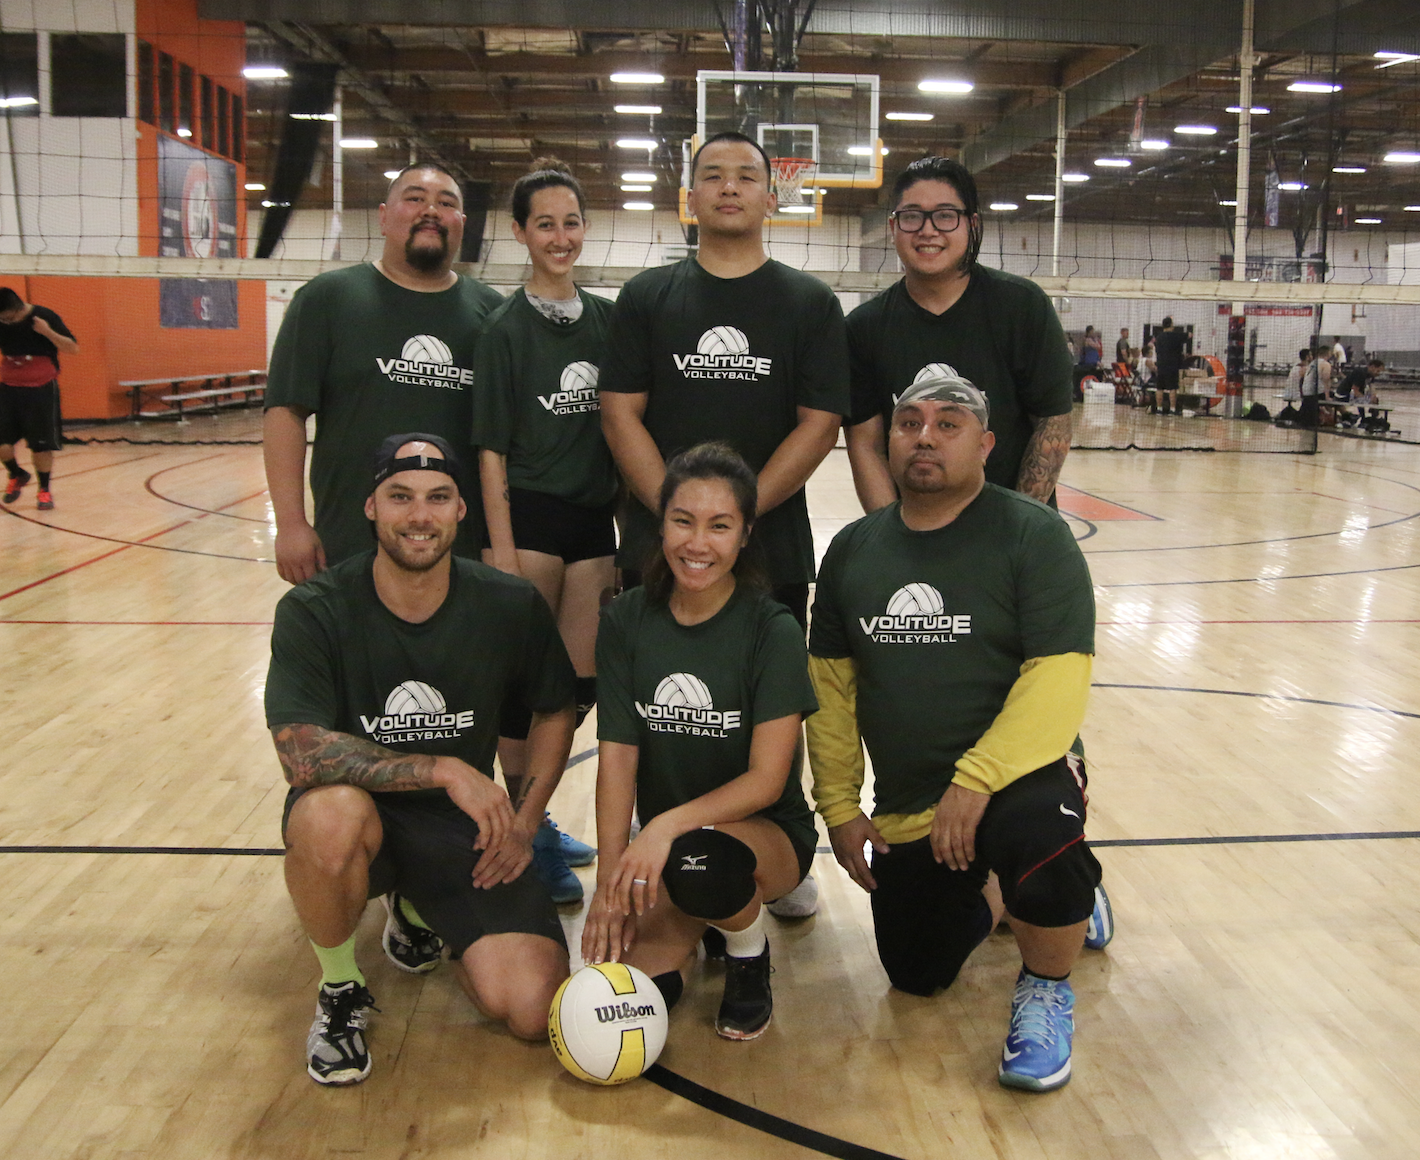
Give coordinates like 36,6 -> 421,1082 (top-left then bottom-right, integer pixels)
582,443 -> 818,1039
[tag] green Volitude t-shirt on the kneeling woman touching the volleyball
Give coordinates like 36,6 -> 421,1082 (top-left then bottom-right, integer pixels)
596,588 -> 818,849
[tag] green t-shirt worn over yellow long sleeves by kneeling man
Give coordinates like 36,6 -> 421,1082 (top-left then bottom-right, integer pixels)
809,483 -> 1095,814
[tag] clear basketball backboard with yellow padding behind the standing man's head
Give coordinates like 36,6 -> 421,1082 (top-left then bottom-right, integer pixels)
680,70 -> 883,226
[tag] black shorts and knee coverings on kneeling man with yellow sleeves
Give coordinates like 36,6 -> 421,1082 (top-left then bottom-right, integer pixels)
872,754 -> 1101,995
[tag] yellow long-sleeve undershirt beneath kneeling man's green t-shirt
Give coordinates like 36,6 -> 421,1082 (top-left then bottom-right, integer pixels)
805,653 -> 1093,843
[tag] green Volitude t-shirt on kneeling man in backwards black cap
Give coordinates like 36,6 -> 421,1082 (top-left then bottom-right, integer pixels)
266,551 -> 575,794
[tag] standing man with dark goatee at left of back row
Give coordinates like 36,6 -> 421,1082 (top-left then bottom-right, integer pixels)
264,163 -> 503,584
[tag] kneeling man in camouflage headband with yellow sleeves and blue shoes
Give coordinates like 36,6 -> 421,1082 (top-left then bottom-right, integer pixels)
808,375 -> 1101,1090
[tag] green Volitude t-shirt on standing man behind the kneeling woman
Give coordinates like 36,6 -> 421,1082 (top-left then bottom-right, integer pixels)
601,258 -> 849,585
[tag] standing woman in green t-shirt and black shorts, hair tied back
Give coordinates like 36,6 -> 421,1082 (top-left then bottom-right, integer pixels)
471,158 -> 616,903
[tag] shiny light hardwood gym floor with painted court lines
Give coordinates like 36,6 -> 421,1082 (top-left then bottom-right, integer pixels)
0,420 -> 1420,1160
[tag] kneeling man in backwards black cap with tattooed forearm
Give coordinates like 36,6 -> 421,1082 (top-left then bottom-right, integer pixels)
266,433 -> 574,1085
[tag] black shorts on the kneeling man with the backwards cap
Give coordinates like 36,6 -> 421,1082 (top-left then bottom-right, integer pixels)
281,789 -> 567,956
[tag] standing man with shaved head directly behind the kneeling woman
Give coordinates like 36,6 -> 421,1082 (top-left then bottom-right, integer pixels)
598,132 -> 848,625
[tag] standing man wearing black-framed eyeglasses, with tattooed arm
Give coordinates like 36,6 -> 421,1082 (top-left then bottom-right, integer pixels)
846,158 -> 1071,511
